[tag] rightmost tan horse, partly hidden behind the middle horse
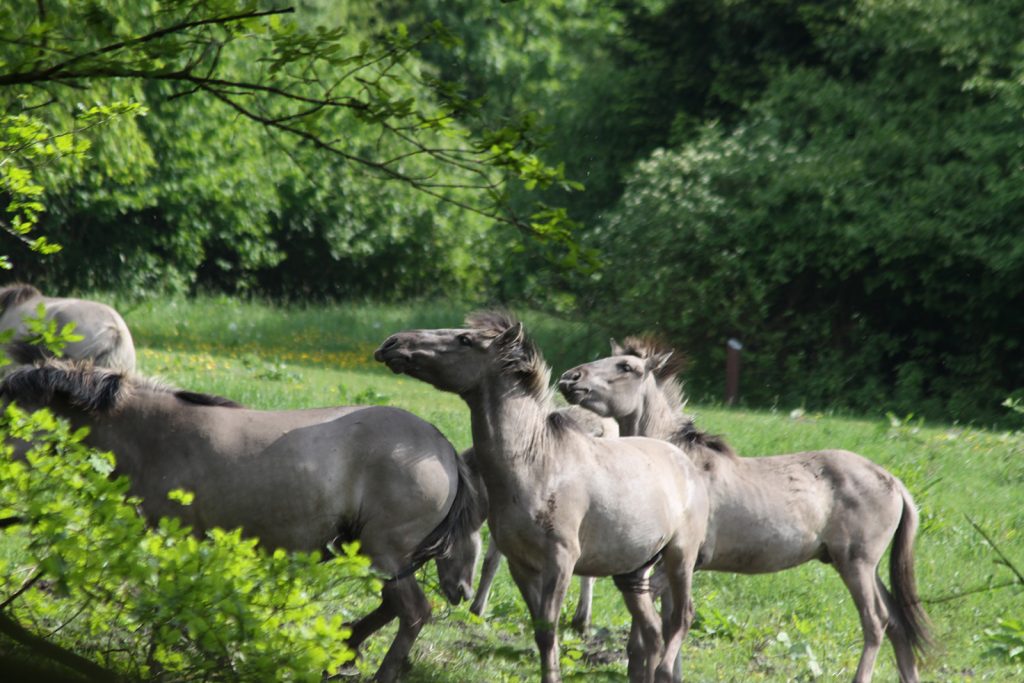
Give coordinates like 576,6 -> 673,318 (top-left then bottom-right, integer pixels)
558,338 -> 929,683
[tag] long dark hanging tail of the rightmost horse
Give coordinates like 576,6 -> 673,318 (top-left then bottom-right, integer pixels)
889,484 -> 932,656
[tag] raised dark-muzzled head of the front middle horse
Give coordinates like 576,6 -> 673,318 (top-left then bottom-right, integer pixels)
374,312 -> 547,395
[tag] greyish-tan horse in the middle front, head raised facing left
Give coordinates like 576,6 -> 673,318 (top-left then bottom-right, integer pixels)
374,312 -> 708,683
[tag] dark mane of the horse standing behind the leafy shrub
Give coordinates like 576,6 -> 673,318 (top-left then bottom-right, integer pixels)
0,358 -> 240,413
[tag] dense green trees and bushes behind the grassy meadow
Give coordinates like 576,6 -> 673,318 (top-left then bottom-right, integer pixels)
0,0 -> 1024,422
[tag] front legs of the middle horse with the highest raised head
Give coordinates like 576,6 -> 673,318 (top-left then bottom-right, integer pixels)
509,545 -> 580,683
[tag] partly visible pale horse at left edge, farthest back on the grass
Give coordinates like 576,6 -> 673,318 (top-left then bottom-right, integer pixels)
0,284 -> 135,372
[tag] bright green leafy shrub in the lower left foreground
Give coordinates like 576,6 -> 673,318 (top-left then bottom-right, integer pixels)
0,404 -> 379,681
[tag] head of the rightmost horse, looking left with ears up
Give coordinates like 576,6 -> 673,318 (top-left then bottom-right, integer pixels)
558,340 -> 672,418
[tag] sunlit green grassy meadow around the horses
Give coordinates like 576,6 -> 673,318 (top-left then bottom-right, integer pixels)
70,297 -> 1024,683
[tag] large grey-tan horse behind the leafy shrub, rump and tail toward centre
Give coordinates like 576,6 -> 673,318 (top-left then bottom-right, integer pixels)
0,359 -> 482,681
